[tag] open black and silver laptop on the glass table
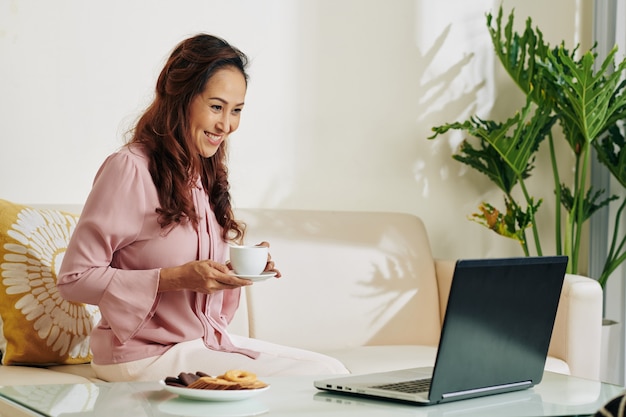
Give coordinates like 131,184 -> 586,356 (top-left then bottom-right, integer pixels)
314,256 -> 567,405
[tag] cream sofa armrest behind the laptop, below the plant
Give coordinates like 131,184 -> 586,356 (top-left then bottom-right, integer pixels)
548,274 -> 603,380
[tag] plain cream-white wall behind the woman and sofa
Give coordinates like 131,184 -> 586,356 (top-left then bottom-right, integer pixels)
0,0 -> 588,258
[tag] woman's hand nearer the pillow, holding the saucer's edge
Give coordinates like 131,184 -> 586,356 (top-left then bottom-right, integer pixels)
159,260 -> 252,294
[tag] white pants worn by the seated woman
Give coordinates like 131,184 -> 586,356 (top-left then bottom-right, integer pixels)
91,335 -> 349,382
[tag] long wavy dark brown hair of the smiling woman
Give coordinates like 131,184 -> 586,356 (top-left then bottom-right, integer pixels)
130,34 -> 248,241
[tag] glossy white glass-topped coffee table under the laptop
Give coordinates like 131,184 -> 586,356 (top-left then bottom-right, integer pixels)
0,372 -> 624,417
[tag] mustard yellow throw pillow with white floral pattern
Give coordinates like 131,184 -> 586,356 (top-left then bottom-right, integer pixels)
0,200 -> 100,365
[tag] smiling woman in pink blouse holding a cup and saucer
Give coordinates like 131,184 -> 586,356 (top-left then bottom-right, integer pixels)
58,34 -> 347,381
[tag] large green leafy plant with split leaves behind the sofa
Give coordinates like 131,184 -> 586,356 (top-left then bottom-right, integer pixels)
429,7 -> 626,288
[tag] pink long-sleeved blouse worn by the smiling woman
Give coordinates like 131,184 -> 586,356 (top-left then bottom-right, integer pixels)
57,146 -> 258,365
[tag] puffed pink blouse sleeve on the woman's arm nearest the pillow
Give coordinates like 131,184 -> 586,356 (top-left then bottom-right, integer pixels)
57,148 -> 159,343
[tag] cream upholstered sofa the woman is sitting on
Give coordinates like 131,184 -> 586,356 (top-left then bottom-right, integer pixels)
0,202 -> 602,385
